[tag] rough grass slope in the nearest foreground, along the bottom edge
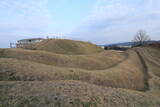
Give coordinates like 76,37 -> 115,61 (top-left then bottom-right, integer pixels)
0,81 -> 160,107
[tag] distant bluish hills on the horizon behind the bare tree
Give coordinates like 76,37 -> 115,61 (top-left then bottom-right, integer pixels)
101,40 -> 160,47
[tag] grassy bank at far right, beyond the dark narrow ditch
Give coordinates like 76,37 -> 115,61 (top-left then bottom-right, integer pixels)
137,47 -> 160,96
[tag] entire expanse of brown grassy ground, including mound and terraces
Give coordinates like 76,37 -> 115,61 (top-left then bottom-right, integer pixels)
0,40 -> 160,107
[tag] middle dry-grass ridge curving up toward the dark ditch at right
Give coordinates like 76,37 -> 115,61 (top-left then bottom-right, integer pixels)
0,51 -> 145,90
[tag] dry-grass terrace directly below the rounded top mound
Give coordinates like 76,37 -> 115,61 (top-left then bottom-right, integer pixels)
0,49 -> 127,70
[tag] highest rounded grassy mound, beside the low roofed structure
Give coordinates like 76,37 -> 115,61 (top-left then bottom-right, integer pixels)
34,39 -> 103,54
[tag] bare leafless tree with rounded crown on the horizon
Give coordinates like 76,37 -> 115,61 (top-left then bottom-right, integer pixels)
133,30 -> 151,46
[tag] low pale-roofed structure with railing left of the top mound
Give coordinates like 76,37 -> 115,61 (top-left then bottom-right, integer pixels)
10,38 -> 44,48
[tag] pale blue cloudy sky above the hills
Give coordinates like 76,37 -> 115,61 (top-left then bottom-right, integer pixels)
0,0 -> 160,48
